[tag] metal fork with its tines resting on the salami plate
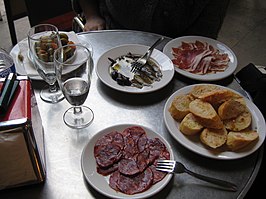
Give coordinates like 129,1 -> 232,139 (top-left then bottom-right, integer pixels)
156,160 -> 237,191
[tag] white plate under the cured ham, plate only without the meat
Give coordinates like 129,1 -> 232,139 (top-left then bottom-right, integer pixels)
163,36 -> 237,81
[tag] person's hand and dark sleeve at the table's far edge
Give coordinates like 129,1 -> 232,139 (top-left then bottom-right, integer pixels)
79,0 -> 105,31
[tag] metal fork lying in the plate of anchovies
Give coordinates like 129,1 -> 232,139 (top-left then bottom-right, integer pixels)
130,37 -> 164,73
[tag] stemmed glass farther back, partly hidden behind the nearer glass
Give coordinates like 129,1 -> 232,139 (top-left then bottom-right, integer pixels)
28,24 -> 64,103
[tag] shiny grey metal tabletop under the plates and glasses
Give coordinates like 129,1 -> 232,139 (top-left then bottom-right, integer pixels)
0,31 -> 263,199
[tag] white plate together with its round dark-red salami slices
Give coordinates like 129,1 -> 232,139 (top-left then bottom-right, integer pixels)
81,124 -> 174,198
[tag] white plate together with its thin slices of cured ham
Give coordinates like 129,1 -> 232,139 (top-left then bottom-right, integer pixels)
163,36 -> 237,81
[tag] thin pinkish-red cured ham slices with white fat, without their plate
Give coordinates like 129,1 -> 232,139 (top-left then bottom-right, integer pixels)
172,41 -> 230,75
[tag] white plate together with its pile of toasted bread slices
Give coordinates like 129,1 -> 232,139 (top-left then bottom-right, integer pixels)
164,84 -> 266,160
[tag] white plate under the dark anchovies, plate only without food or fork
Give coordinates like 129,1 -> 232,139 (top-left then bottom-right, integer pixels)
96,44 -> 175,93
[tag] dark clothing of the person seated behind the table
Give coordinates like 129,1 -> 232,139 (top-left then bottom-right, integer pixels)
73,0 -> 229,38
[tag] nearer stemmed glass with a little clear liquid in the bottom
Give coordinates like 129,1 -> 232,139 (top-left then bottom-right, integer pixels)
54,44 -> 94,129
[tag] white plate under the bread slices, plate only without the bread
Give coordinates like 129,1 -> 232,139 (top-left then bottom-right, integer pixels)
164,84 -> 266,160
